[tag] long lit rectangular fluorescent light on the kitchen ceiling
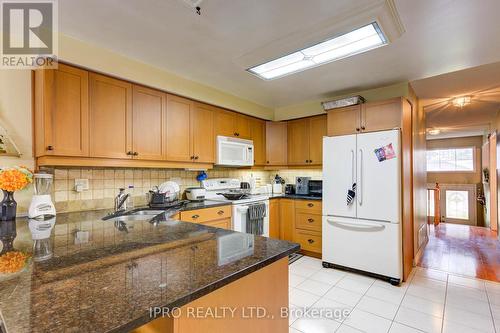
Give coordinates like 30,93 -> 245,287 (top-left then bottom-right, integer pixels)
247,22 -> 387,80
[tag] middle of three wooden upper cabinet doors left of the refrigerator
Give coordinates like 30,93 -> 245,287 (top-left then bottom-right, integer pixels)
288,118 -> 309,165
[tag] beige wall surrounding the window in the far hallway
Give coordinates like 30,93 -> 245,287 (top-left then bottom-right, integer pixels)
427,136 -> 483,184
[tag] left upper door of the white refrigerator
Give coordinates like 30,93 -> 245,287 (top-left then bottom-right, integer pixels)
323,134 -> 356,218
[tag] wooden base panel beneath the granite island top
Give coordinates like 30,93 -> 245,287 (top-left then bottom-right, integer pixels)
132,258 -> 288,333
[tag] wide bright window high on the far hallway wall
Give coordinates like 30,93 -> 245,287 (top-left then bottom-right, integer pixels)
427,147 -> 474,172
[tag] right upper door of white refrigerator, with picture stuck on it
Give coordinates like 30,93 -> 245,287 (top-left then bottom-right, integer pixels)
356,130 -> 401,223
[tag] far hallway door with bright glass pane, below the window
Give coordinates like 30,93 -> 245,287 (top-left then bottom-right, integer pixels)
439,184 -> 477,226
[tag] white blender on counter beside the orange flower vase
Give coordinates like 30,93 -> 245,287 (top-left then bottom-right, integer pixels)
28,173 -> 56,220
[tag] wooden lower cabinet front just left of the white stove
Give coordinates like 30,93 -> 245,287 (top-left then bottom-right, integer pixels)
179,205 -> 232,229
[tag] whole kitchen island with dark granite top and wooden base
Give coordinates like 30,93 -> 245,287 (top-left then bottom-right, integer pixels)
0,211 -> 299,333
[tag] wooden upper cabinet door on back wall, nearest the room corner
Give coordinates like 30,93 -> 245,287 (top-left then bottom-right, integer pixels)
266,121 -> 287,165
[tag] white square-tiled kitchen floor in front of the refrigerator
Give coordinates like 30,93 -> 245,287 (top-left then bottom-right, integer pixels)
289,257 -> 500,333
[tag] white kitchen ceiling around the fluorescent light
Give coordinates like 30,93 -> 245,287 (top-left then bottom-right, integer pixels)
59,0 -> 500,108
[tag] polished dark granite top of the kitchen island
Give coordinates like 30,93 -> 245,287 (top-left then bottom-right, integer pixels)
0,211 -> 299,333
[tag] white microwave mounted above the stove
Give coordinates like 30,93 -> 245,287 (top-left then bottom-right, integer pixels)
216,135 -> 254,166
